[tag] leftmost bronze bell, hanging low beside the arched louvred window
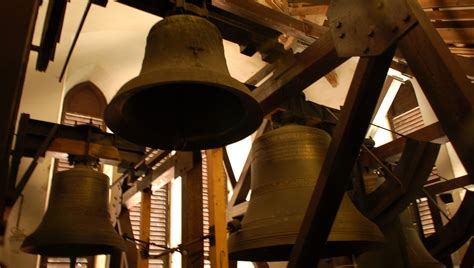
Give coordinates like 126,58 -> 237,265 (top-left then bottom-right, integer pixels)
21,165 -> 125,257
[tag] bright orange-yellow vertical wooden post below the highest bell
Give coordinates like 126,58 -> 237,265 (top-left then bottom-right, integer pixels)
206,149 -> 229,268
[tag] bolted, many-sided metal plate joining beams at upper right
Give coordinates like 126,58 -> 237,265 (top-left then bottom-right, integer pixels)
327,0 -> 416,57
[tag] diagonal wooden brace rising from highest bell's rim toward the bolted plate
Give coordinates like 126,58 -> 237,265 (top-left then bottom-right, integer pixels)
253,33 -> 347,114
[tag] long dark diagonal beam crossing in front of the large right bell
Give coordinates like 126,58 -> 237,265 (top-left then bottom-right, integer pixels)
288,47 -> 395,268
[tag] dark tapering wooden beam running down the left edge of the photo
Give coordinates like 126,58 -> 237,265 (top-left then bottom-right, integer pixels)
0,0 -> 41,234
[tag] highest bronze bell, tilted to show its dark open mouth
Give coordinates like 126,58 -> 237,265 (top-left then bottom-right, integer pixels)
105,15 -> 263,150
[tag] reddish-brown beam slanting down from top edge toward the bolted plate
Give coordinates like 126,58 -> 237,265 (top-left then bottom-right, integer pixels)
212,0 -> 327,41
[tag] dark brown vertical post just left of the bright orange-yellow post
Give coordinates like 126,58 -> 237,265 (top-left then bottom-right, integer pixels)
180,151 -> 204,268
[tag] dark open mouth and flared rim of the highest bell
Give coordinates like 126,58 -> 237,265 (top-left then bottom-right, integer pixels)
104,71 -> 263,151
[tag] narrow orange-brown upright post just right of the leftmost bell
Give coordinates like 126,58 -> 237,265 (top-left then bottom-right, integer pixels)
138,188 -> 151,268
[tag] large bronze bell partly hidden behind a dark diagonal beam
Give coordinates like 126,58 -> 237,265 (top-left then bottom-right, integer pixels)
228,125 -> 383,261
